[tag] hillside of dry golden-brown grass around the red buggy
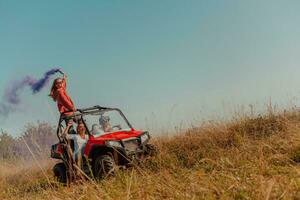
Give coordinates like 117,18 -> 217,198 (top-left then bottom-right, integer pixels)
0,109 -> 300,200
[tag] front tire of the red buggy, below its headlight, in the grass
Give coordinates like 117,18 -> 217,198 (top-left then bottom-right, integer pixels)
93,155 -> 116,180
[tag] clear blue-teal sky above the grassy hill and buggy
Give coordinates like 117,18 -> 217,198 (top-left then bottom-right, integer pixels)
0,0 -> 300,135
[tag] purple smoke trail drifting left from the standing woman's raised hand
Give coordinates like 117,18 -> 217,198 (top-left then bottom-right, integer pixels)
0,68 -> 62,116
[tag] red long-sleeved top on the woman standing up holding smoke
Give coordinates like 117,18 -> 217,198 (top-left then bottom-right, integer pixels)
56,78 -> 75,115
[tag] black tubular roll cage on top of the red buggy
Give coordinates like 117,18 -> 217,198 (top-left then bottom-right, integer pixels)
56,105 -> 133,142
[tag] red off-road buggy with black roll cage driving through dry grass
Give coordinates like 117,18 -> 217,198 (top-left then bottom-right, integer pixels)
51,106 -> 157,183
